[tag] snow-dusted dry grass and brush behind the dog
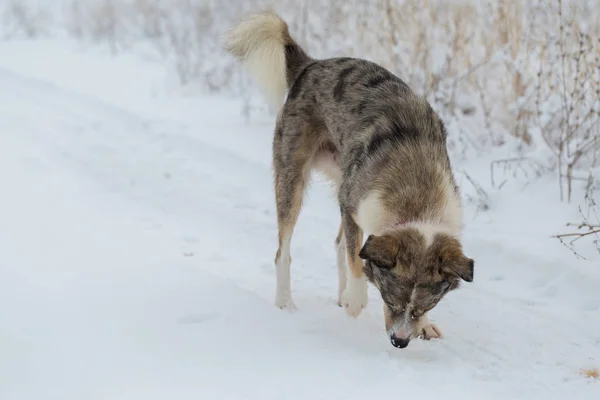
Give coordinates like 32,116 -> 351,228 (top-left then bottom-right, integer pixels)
0,0 -> 600,252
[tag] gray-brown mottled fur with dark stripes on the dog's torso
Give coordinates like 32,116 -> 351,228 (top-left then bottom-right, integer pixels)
274,54 -> 457,233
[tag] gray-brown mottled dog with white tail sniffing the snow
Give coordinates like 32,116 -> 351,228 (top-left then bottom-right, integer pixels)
224,12 -> 474,348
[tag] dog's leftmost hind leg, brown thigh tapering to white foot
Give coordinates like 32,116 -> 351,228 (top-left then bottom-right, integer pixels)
273,123 -> 316,309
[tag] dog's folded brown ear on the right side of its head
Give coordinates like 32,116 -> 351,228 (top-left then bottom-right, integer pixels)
431,235 -> 475,282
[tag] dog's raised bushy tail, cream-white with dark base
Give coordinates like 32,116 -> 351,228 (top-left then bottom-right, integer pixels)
225,13 -> 312,111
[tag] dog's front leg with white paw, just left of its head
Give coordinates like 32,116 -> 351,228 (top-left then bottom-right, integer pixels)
341,214 -> 368,317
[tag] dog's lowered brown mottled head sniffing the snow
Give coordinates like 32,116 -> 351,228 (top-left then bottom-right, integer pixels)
360,228 -> 474,348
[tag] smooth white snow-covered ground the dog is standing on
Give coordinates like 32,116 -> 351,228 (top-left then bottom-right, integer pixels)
0,41 -> 600,400
